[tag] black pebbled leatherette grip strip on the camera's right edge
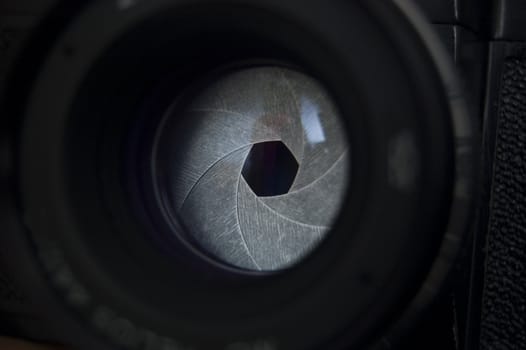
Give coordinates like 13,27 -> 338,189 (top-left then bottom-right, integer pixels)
481,58 -> 526,350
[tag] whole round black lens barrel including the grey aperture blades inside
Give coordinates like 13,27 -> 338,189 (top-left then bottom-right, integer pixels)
0,0 -> 476,350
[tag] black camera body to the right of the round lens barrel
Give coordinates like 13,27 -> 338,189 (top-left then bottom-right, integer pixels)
420,1 -> 526,349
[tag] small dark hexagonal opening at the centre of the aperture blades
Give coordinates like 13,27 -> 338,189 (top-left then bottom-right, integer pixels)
241,141 -> 298,197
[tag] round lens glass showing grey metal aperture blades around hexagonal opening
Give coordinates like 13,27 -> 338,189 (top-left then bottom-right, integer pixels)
152,65 -> 349,271
